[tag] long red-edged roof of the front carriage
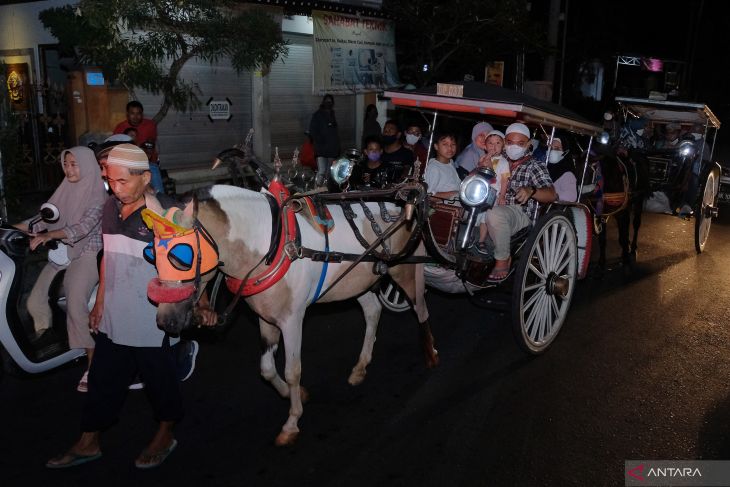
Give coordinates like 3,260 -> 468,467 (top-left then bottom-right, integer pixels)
383,81 -> 603,136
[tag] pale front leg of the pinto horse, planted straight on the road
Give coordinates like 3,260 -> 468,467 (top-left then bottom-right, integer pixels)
275,314 -> 304,446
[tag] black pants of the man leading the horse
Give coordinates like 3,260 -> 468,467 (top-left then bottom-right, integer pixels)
81,333 -> 183,432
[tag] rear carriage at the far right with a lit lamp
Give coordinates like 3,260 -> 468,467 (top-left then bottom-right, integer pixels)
616,97 -> 722,253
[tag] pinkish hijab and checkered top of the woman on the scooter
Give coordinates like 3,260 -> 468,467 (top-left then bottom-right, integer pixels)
47,146 -> 107,260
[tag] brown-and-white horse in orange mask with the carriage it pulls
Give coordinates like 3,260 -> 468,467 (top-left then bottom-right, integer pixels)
145,83 -> 601,445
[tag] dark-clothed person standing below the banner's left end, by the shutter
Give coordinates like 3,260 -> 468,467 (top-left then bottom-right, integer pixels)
309,94 -> 340,186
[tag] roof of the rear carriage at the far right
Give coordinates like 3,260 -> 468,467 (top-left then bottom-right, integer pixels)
615,96 -> 721,129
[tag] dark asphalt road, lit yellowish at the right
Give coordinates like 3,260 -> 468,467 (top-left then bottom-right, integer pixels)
0,211 -> 730,487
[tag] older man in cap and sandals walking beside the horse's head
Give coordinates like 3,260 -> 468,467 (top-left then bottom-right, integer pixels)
46,144 -> 183,469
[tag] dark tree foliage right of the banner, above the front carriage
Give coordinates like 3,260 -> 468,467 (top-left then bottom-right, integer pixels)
383,0 -> 547,86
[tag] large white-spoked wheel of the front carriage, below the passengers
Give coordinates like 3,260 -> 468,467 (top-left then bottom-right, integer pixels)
512,213 -> 578,354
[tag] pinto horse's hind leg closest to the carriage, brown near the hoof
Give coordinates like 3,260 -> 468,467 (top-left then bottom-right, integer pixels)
391,262 -> 439,369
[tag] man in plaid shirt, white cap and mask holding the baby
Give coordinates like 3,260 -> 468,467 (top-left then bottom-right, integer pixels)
486,122 -> 557,282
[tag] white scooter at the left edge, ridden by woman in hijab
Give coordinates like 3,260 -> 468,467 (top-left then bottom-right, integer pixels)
0,203 -> 86,374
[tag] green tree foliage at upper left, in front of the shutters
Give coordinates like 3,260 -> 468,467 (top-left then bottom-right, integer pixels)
39,0 -> 287,122
